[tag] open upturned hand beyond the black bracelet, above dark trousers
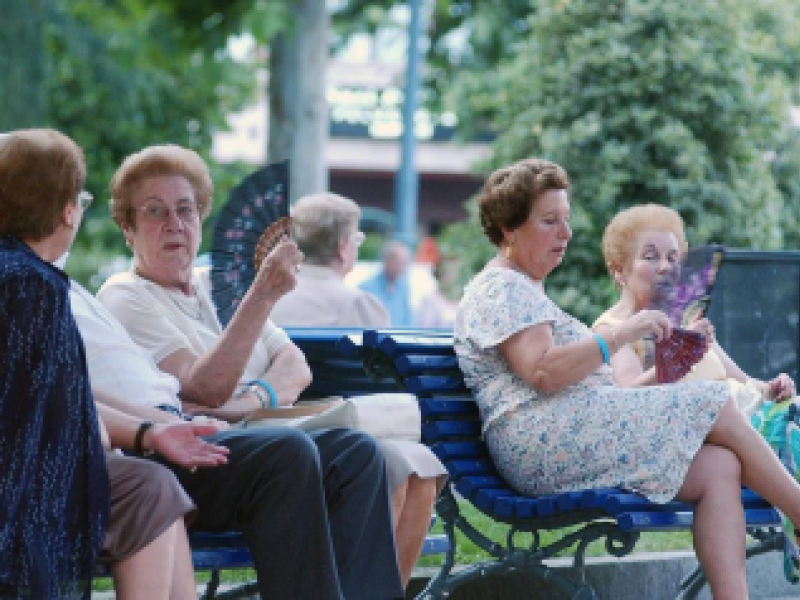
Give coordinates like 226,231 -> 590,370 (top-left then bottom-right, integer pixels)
142,421 -> 229,469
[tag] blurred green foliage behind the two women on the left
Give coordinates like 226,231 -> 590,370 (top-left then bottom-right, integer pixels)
39,0 -> 255,286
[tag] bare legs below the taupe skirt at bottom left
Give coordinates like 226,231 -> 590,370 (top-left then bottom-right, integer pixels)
114,519 -> 197,600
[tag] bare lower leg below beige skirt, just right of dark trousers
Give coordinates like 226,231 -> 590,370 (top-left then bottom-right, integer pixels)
395,475 -> 436,587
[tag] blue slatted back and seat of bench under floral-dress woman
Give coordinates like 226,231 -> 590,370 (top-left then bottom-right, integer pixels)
361,331 -> 780,531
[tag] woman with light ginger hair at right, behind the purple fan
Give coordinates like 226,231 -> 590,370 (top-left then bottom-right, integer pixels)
593,204 -> 800,582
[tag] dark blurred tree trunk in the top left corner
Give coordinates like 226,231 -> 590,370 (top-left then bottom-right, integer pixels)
0,0 -> 48,131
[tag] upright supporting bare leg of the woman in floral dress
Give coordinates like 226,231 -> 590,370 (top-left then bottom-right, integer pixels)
677,444 -> 747,600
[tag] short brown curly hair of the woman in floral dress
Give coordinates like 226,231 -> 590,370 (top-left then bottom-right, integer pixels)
478,158 -> 569,246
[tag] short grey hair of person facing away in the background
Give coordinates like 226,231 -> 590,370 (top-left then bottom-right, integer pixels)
292,192 -> 361,265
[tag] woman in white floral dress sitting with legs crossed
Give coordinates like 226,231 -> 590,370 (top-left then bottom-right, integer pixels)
454,159 -> 800,599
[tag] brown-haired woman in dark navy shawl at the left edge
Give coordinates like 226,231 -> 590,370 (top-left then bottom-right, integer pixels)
0,130 -> 108,599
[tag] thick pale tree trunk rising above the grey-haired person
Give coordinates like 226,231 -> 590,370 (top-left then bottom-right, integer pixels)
267,0 -> 330,200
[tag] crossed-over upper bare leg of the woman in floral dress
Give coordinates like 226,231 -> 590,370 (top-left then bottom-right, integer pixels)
706,401 -> 800,525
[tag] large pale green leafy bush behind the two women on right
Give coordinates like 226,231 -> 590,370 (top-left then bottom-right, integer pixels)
444,0 -> 800,319
